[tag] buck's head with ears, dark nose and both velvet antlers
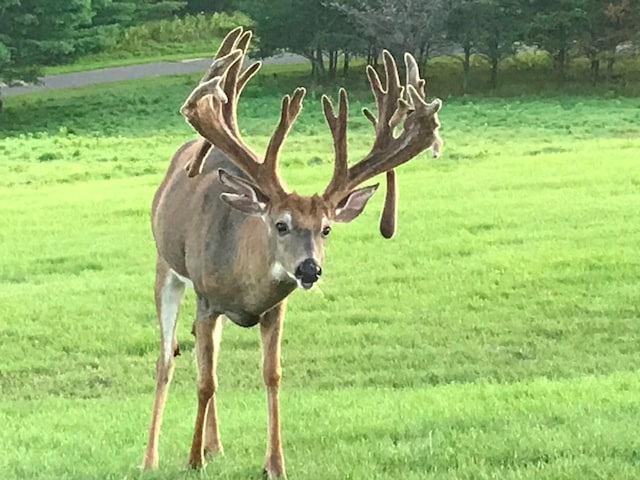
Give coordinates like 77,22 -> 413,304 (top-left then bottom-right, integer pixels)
181,28 -> 442,289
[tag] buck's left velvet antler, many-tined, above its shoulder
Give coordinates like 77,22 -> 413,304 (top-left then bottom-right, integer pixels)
180,27 -> 305,196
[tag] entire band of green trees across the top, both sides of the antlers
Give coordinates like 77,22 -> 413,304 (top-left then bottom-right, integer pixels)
0,0 -> 640,91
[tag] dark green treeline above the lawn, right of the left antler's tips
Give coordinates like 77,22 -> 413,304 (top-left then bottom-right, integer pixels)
241,0 -> 640,88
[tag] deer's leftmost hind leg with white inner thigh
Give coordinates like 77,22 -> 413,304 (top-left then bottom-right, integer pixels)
143,257 -> 184,469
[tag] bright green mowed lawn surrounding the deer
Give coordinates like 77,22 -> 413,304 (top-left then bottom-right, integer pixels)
0,77 -> 640,480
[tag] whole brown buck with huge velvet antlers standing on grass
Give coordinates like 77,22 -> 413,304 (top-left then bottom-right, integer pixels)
143,28 -> 441,478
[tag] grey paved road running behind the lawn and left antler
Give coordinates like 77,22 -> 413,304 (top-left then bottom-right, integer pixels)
2,53 -> 305,97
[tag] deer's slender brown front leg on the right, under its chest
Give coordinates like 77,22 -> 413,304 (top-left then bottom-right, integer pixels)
260,301 -> 286,479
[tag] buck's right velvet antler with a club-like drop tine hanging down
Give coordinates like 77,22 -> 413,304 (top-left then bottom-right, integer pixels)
322,50 -> 442,238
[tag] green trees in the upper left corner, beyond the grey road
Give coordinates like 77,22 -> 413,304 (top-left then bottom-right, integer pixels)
0,0 -> 224,80
